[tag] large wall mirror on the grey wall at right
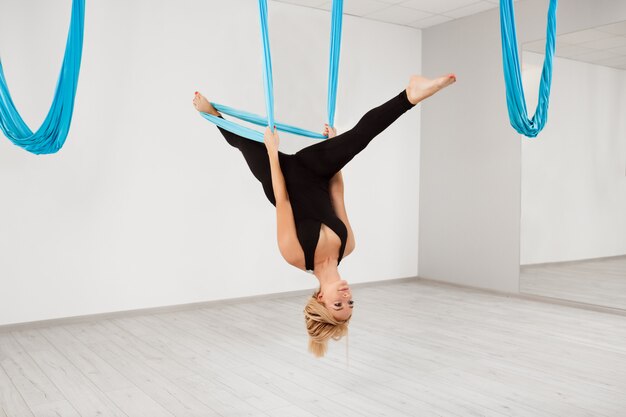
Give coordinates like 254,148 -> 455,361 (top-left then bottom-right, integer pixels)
520,21 -> 626,310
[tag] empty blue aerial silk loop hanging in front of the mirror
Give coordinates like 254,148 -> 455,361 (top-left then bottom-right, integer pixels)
500,0 -> 557,138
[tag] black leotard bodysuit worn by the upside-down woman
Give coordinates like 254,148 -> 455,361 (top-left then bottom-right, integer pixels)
218,91 -> 413,272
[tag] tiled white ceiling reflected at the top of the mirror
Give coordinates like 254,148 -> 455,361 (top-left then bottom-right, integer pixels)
522,21 -> 626,70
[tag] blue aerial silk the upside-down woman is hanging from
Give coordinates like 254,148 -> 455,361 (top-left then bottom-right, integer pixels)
200,0 -> 343,142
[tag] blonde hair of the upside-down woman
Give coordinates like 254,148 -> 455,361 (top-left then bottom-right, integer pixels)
304,290 -> 350,358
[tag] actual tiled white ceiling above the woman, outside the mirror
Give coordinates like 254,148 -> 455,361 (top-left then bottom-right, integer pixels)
275,0 -> 517,29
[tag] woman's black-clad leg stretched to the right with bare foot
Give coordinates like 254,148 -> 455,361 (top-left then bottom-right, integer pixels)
296,75 -> 455,178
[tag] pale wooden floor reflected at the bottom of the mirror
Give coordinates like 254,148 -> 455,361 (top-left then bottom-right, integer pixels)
520,256 -> 626,308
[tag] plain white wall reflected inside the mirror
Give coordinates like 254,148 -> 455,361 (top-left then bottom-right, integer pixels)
521,52 -> 626,265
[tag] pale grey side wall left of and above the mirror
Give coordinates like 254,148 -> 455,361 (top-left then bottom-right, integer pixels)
419,0 -> 626,292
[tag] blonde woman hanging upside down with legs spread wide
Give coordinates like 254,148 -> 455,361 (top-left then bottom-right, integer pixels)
193,74 -> 456,357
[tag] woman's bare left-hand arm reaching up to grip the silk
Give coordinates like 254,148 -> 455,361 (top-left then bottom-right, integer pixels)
264,127 -> 304,268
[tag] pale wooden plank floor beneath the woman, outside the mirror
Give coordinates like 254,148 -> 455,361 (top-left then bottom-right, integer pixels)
0,281 -> 626,417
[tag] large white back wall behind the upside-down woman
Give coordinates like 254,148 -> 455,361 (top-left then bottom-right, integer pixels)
0,0 -> 421,324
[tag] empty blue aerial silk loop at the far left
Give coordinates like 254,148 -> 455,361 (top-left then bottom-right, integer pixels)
0,0 -> 85,154
